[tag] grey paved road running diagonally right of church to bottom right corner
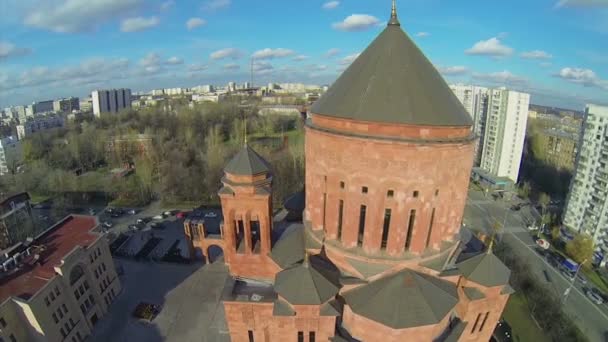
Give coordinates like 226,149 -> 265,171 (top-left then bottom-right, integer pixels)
464,191 -> 608,342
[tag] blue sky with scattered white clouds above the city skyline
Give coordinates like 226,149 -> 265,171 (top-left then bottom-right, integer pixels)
0,0 -> 608,109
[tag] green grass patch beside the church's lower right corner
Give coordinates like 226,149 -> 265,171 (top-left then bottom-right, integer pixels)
503,293 -> 549,342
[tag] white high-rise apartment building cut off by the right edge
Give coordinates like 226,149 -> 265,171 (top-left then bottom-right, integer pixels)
564,104 -> 608,256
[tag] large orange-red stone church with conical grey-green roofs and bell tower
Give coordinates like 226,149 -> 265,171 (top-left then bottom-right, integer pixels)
185,1 -> 513,342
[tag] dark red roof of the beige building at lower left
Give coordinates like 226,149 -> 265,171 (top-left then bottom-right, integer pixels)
0,215 -> 99,303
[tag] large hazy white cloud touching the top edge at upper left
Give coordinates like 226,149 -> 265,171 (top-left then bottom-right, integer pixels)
24,0 -> 144,33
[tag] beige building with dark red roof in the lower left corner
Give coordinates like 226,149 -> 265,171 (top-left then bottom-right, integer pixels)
0,215 -> 121,342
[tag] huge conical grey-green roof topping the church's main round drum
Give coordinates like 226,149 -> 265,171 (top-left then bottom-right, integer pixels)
311,16 -> 473,127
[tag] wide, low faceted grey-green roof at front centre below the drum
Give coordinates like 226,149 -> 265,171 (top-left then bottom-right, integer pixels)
344,270 -> 458,329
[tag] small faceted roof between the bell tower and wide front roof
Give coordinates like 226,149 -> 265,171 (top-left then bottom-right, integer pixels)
274,260 -> 340,305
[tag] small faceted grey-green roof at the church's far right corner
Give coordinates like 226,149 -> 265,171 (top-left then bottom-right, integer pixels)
456,252 -> 511,287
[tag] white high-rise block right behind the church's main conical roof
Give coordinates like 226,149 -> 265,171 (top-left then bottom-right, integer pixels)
451,85 -> 530,183
